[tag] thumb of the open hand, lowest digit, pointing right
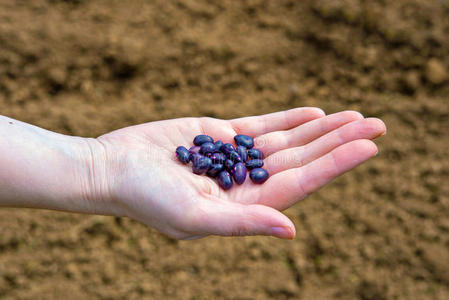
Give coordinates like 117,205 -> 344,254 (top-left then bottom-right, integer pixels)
191,202 -> 295,239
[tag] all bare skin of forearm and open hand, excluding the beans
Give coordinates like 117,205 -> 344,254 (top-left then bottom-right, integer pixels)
0,107 -> 386,239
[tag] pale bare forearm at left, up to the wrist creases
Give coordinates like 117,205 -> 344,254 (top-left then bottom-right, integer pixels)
0,116 -> 114,214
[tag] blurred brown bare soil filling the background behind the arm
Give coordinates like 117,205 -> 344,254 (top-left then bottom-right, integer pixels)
0,0 -> 449,299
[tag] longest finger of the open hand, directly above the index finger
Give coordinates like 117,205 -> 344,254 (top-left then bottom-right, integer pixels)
265,118 -> 386,175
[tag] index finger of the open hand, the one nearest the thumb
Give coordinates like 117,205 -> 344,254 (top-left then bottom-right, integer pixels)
257,140 -> 377,210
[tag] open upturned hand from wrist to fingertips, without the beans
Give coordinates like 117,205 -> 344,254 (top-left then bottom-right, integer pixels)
92,108 -> 386,239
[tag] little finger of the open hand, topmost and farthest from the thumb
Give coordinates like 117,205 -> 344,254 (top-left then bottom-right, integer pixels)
230,107 -> 326,137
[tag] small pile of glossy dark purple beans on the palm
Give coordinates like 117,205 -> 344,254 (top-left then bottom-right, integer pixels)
176,134 -> 269,190
